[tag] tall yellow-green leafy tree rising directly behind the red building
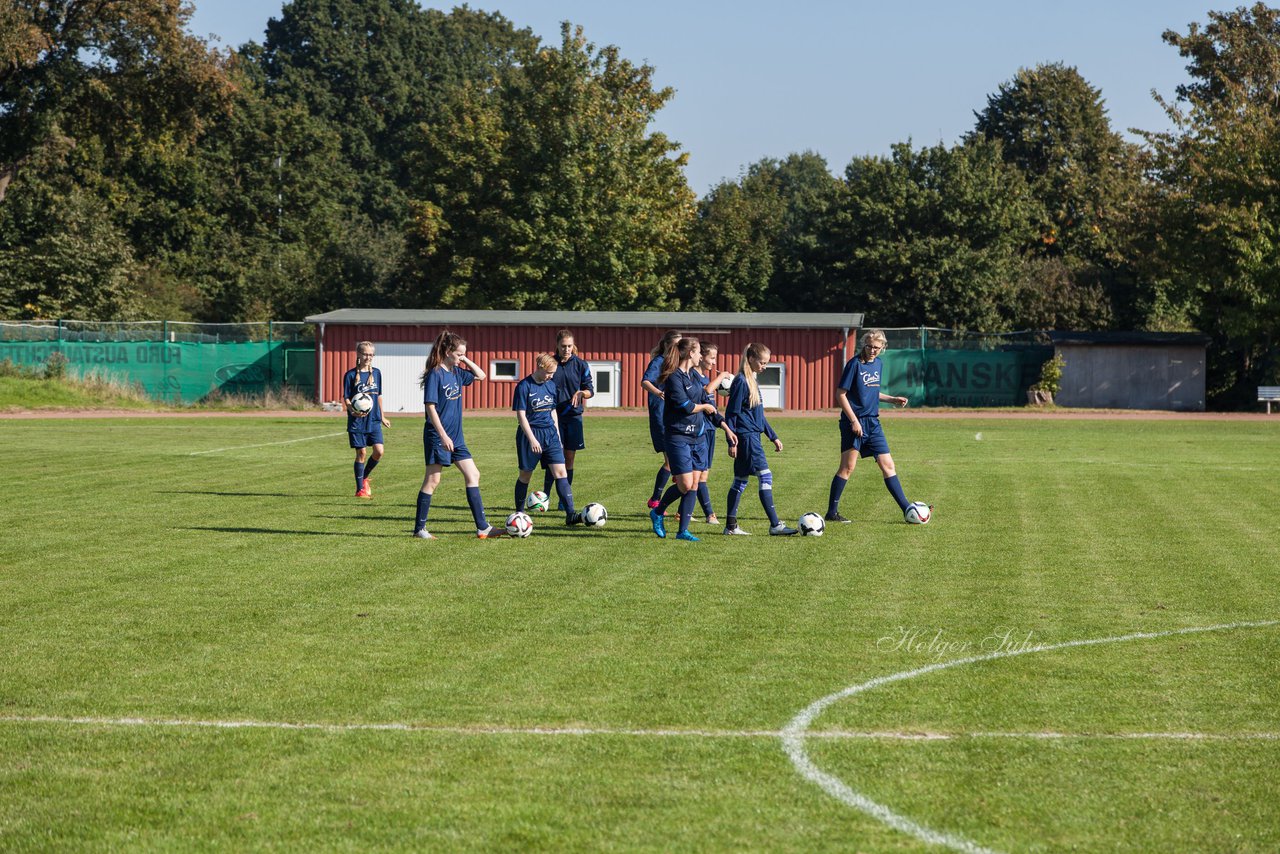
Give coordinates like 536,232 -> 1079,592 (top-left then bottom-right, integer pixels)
402,24 -> 694,310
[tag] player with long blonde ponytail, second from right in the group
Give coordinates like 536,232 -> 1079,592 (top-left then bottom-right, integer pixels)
724,344 -> 796,536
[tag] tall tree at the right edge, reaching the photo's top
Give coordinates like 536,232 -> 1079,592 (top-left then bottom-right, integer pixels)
1147,3 -> 1280,406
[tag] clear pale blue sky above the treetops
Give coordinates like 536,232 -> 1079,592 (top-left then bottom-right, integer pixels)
191,0 -> 1208,196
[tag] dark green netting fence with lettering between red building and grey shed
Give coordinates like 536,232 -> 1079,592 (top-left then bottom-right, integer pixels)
882,326 -> 1053,406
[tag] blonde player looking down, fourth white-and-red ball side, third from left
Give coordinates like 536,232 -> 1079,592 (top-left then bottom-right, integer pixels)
511,353 -> 581,525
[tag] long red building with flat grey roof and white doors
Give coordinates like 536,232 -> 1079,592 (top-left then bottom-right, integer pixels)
306,309 -> 863,412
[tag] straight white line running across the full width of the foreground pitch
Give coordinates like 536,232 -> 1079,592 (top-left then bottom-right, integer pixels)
0,714 -> 1280,741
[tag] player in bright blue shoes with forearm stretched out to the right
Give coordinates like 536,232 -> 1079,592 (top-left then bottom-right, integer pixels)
649,338 -> 737,543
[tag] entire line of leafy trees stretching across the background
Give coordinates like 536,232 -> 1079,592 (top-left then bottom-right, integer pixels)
0,0 -> 1280,406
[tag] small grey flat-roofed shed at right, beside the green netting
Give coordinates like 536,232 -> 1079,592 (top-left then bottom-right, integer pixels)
1050,332 -> 1210,412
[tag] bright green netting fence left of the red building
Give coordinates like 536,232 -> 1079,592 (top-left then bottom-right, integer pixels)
0,321 -> 316,403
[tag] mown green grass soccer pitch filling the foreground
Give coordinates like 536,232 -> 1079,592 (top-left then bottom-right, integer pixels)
0,416 -> 1280,851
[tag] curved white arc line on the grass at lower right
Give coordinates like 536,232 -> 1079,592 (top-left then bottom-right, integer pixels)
782,620 -> 1280,854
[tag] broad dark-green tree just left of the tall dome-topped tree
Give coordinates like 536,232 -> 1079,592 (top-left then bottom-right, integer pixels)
818,140 -> 1038,332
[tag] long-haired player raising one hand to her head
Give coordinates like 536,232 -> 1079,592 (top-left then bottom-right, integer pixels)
413,329 -> 506,539
